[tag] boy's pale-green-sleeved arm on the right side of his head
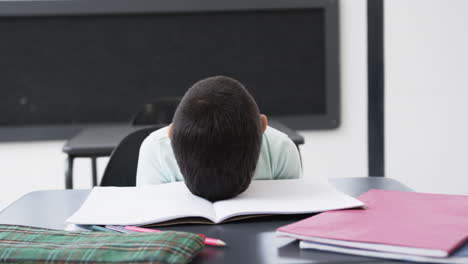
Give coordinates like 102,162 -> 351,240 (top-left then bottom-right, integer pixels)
273,136 -> 302,179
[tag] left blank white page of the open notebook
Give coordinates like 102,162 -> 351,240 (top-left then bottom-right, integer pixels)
67,182 -> 215,225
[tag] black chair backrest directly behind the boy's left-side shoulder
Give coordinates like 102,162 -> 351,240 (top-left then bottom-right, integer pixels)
99,125 -> 164,186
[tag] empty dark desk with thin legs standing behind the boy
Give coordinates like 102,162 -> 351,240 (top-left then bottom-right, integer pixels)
63,120 -> 304,189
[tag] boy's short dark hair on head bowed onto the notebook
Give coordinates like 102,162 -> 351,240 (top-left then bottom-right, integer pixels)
171,76 -> 263,201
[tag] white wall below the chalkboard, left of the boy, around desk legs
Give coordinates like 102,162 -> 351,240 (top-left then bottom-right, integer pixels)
0,140 -> 108,211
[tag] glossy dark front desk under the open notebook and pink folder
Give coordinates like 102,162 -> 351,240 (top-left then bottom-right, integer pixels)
0,177 -> 411,264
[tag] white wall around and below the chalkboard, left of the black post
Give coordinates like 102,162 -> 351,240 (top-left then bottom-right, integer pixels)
0,0 -> 367,208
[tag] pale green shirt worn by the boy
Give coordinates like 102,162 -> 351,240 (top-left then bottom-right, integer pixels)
136,127 -> 302,186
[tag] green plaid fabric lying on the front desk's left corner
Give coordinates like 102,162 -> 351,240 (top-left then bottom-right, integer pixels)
0,225 -> 204,264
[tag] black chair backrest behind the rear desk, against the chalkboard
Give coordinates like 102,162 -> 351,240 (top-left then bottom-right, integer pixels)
131,97 -> 180,125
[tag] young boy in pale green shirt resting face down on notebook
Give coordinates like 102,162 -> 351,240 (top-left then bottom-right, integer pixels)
137,76 -> 302,201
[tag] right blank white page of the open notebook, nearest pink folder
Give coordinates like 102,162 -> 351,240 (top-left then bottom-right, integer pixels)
214,180 -> 363,222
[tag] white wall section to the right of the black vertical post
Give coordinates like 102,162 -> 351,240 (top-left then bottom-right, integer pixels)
385,0 -> 468,194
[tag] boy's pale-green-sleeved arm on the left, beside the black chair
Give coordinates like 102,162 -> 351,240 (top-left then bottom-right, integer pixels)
136,137 -> 168,186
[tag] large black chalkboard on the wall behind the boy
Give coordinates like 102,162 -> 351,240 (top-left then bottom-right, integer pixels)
0,0 -> 339,128
